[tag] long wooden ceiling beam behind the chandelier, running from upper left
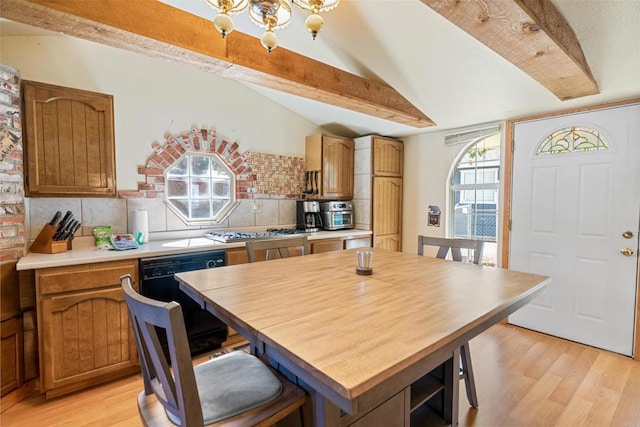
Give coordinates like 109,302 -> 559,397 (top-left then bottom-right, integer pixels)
0,0 -> 435,128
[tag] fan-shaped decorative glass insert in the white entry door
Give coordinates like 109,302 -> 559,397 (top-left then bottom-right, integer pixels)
536,126 -> 609,156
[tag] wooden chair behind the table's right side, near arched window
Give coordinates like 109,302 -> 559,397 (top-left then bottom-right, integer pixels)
418,236 -> 484,408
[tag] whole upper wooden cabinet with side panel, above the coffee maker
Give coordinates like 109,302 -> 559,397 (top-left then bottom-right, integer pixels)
306,134 -> 355,200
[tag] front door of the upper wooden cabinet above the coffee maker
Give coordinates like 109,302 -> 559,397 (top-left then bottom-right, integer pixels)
320,136 -> 355,199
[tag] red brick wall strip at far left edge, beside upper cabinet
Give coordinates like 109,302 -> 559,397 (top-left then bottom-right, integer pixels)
0,64 -> 27,261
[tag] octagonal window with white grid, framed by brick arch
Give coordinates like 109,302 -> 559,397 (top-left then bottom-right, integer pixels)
165,153 -> 237,225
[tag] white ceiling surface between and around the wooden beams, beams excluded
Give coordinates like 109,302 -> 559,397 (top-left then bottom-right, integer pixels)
2,0 -> 640,137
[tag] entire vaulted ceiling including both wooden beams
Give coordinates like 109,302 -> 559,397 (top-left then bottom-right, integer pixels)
0,0 -> 640,136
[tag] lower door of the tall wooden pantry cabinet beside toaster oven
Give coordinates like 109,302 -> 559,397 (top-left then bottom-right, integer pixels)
372,177 -> 402,251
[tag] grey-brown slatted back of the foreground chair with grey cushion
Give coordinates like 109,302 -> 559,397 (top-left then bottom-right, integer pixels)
120,275 -> 204,426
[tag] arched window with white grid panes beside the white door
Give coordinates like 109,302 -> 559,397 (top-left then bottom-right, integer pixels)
448,130 -> 501,265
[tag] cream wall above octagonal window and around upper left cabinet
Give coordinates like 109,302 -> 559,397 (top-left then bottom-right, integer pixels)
0,35 -> 318,190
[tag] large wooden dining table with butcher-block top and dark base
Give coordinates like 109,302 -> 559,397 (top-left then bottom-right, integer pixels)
176,248 -> 550,427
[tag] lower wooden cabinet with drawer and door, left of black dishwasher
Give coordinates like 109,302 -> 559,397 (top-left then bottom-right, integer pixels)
36,260 -> 139,398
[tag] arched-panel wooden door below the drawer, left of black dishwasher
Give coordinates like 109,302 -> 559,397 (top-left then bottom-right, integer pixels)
40,286 -> 137,397
